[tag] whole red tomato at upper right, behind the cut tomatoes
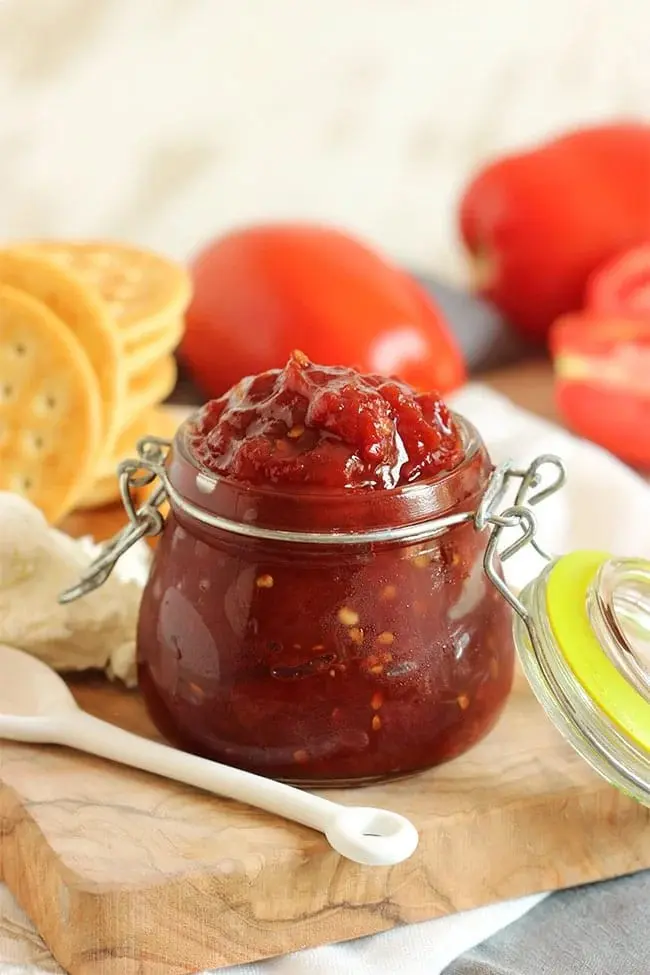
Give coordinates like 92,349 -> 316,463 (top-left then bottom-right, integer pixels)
459,122 -> 650,341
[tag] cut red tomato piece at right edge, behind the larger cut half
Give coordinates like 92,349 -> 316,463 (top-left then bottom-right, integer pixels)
585,242 -> 650,321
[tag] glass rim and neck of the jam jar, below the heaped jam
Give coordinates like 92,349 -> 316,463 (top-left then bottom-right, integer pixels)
165,413 -> 493,544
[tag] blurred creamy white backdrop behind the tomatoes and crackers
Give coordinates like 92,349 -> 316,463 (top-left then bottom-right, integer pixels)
0,0 -> 650,277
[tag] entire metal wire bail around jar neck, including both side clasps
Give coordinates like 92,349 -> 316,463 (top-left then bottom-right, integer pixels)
59,437 -> 566,620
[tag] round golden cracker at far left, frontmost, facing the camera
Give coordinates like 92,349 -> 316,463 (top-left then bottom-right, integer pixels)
0,285 -> 102,522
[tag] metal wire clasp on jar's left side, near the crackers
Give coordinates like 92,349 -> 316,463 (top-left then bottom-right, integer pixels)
58,437 -> 171,603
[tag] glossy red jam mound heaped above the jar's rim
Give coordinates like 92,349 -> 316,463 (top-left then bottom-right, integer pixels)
189,352 -> 463,490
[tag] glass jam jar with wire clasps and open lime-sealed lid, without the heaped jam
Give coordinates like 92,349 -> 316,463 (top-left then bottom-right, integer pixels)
60,417 -> 650,806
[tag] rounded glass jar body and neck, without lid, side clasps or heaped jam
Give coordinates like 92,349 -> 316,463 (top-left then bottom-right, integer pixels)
64,420 -> 514,786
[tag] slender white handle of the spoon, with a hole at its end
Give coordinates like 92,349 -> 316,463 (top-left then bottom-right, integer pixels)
50,710 -> 418,866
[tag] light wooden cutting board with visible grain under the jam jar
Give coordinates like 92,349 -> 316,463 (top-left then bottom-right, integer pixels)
5,366 -> 650,975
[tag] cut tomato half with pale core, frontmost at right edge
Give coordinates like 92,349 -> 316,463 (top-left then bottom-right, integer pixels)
550,312 -> 650,470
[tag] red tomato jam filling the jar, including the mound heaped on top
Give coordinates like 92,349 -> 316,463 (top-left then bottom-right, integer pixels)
138,353 -> 514,786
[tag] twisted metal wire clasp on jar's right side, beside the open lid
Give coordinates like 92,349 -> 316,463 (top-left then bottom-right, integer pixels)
474,454 -> 566,627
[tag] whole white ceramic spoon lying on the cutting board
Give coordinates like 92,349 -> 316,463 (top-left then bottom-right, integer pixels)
0,644 -> 418,867
